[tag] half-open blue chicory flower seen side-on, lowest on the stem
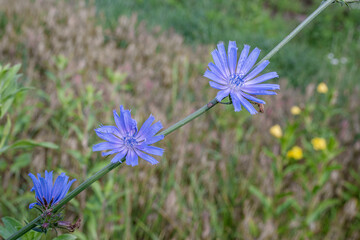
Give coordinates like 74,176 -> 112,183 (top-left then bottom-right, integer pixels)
29,171 -> 76,209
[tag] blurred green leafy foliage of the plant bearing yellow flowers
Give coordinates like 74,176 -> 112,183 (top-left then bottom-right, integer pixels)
258,86 -> 354,237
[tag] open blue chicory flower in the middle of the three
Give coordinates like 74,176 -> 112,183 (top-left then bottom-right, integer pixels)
93,106 -> 164,166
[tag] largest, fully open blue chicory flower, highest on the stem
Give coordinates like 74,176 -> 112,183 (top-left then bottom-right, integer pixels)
204,41 -> 280,114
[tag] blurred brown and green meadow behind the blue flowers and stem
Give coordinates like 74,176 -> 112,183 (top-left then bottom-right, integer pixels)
0,0 -> 360,239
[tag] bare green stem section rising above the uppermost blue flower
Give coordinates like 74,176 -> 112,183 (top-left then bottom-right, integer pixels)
256,0 -> 335,65
